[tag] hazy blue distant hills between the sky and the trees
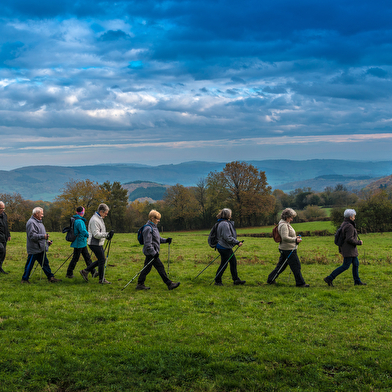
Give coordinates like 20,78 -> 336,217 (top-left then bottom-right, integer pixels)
0,159 -> 392,201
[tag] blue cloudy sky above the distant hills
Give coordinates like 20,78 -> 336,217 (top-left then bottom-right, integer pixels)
0,0 -> 392,170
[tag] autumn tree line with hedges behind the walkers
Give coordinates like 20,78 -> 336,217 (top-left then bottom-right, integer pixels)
0,161 -> 392,233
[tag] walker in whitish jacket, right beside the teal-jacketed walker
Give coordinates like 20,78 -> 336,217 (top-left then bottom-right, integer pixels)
79,203 -> 114,284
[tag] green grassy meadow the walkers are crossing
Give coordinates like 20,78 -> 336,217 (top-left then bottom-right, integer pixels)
0,222 -> 392,392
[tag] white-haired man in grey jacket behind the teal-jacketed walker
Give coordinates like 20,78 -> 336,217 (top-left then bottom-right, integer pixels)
21,207 -> 61,283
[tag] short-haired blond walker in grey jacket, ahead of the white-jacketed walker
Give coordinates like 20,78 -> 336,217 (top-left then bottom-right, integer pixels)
136,210 -> 180,290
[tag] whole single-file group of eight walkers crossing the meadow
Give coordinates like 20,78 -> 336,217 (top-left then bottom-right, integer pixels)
0,201 -> 366,290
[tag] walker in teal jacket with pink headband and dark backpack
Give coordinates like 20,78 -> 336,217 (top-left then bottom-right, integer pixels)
65,206 -> 98,279
